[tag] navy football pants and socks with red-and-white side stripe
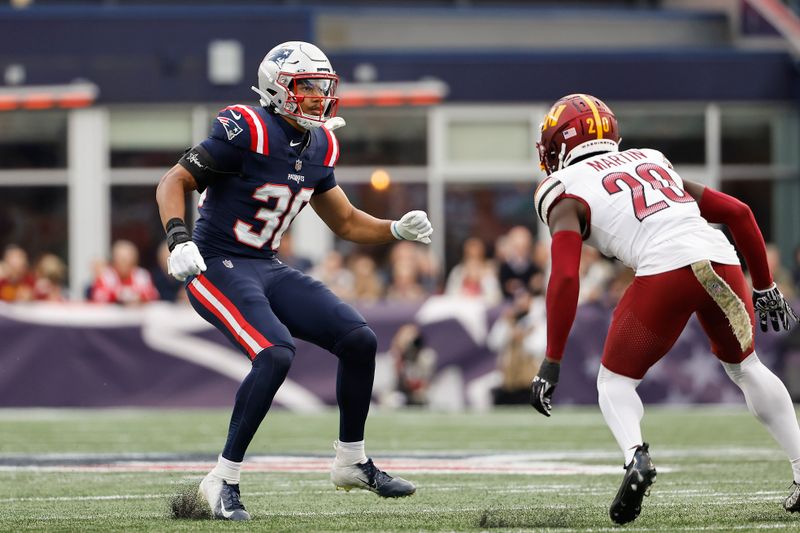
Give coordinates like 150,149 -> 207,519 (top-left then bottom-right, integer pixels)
186,256 -> 377,462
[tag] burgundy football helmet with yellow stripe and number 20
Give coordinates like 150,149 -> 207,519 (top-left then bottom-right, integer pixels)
536,94 -> 620,175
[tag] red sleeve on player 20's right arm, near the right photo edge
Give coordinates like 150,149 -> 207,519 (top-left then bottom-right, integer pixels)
699,187 -> 772,289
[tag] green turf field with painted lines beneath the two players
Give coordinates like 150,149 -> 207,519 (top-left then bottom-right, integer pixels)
0,406 -> 800,532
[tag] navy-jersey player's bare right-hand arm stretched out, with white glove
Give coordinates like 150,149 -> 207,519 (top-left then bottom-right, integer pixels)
310,186 -> 433,244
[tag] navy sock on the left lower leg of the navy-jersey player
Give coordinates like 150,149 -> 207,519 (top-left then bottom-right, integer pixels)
222,346 -> 294,463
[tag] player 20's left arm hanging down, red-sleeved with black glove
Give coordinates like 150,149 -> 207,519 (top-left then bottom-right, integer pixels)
531,198 -> 583,416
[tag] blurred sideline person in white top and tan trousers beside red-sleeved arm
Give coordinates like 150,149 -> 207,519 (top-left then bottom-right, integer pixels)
486,288 -> 547,405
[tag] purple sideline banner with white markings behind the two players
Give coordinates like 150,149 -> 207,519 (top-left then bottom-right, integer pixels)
0,296 -> 788,410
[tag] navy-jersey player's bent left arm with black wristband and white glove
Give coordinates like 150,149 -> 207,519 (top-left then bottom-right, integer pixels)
156,165 -> 206,281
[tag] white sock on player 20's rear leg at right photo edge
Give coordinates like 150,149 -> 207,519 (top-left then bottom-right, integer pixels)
722,352 -> 800,483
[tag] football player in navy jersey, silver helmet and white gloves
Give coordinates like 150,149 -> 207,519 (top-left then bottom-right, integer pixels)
156,41 -> 433,520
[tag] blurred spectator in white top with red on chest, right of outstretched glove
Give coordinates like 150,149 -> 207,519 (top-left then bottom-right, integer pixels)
444,237 -> 503,305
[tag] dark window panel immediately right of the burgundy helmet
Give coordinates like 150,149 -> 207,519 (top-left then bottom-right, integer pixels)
615,106 -> 706,165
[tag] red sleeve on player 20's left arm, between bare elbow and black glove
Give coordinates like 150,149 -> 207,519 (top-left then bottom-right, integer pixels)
546,231 -> 583,361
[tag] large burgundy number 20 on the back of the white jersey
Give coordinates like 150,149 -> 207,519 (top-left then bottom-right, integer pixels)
603,163 -> 694,222
